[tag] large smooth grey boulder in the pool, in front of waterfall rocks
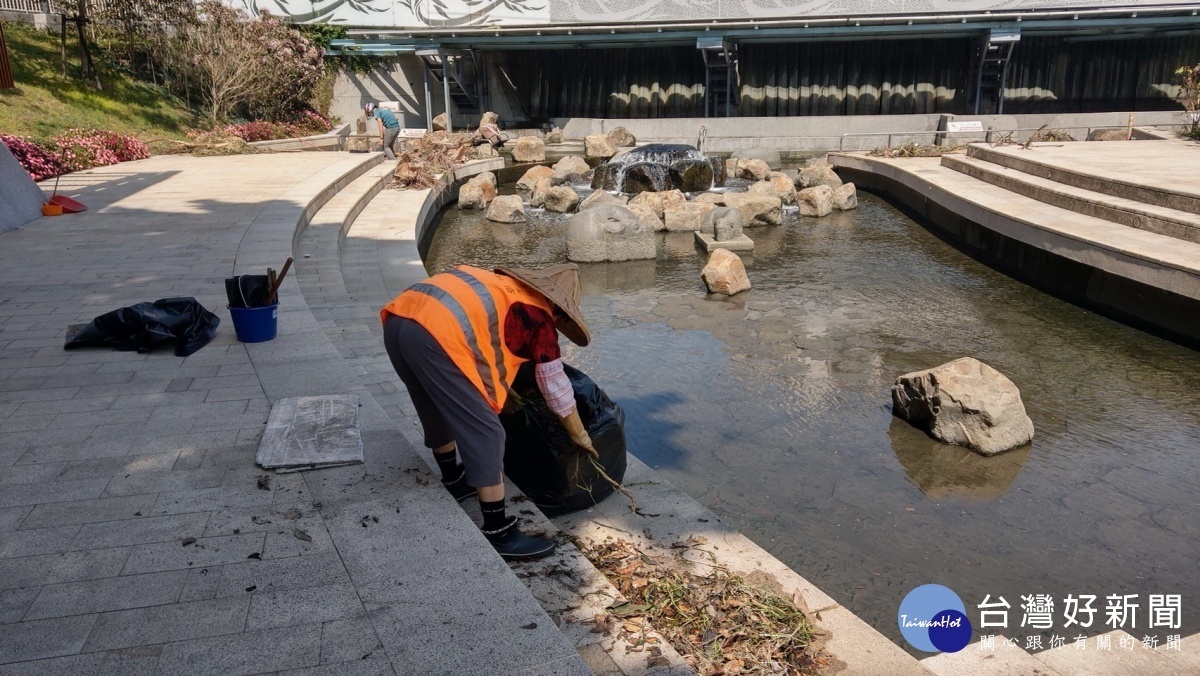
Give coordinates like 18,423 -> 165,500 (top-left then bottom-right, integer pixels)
566,204 -> 656,263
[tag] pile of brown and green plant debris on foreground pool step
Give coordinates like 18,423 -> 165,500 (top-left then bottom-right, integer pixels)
577,538 -> 824,676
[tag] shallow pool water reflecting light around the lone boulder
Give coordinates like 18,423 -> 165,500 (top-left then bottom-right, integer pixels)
427,182 -> 1200,645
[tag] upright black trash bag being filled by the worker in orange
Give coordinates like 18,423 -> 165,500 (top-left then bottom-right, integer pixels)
500,363 -> 625,516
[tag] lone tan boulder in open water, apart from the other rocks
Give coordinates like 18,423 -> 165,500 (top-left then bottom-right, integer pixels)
892,357 -> 1033,455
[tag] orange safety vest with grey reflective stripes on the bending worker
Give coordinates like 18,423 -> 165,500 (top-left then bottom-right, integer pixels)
379,265 -> 552,413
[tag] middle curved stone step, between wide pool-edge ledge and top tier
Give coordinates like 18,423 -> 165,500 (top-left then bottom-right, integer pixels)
942,155 -> 1200,243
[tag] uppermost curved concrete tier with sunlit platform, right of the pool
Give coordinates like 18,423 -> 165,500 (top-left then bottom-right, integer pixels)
967,140 -> 1200,214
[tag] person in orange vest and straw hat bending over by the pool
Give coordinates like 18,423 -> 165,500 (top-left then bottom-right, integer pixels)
379,263 -> 598,558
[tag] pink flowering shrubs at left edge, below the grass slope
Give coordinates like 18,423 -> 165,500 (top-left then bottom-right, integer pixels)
0,130 -> 150,181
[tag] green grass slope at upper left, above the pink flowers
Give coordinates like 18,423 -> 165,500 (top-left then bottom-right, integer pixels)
0,23 -> 193,140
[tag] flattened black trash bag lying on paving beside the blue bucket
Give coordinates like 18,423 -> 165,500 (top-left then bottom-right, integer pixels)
64,298 -> 221,357
